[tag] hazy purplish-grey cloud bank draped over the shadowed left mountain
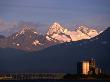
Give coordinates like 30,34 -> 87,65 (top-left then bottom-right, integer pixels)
0,19 -> 48,36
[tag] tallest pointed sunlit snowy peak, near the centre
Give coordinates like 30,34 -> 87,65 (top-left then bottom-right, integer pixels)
46,22 -> 71,42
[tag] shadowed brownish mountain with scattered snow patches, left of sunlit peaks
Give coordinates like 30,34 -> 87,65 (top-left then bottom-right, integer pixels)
0,26 -> 46,51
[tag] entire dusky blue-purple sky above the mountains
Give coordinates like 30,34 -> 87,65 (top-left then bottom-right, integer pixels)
0,0 -> 110,32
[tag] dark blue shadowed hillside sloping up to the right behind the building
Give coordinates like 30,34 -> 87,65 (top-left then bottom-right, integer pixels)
0,27 -> 110,73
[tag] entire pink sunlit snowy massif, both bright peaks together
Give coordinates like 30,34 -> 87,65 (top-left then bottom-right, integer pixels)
46,22 -> 98,43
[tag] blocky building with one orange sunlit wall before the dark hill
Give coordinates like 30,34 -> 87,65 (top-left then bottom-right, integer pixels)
77,59 -> 102,75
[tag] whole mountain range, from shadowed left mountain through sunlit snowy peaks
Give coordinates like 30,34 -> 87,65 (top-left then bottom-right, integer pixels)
0,22 -> 99,51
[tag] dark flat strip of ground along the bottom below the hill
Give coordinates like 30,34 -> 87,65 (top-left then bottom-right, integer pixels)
0,73 -> 110,82
